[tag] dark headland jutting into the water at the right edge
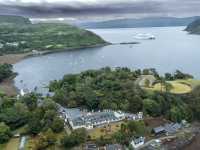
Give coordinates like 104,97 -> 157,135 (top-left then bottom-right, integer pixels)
185,19 -> 200,34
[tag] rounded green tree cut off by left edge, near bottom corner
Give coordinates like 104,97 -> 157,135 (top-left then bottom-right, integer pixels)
0,122 -> 11,144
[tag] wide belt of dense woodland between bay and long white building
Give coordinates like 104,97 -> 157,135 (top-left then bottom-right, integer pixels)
49,67 -> 198,121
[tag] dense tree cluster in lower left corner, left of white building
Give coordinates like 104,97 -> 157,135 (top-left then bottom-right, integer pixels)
0,93 -> 64,150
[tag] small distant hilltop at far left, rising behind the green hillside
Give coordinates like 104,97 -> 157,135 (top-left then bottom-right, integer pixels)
0,15 -> 31,24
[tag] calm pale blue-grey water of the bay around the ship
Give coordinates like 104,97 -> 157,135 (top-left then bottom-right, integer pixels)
14,27 -> 200,92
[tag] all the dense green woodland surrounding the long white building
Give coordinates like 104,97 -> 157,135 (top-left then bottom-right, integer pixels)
0,67 -> 200,150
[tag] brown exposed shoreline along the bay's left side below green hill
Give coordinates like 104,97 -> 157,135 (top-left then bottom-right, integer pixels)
0,42 -> 111,96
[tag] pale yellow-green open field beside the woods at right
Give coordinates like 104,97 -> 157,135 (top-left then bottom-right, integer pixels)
145,79 -> 200,94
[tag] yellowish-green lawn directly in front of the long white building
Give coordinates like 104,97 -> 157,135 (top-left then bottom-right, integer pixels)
89,121 -> 123,140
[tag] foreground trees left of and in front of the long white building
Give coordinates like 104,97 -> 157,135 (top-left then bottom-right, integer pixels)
0,93 -> 147,150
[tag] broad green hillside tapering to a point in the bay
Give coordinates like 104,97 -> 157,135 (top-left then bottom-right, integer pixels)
0,21 -> 106,54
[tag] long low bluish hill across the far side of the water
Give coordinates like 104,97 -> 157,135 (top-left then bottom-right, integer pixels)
78,16 -> 200,28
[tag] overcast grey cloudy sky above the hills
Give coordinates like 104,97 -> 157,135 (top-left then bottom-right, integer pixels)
0,0 -> 200,20
